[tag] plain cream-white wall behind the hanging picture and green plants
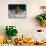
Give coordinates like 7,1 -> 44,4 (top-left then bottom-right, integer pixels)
0,0 -> 46,36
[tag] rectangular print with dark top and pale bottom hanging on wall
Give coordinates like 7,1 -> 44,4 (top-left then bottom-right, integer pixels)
8,4 -> 26,18
